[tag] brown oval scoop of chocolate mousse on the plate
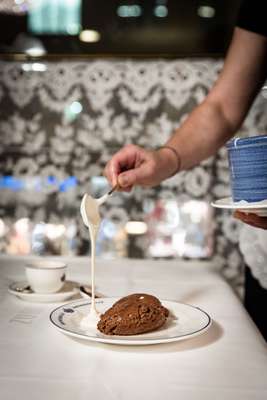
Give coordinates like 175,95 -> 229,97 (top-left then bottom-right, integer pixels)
97,293 -> 169,335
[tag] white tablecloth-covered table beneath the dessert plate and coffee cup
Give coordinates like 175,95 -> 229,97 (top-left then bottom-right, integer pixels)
0,257 -> 267,400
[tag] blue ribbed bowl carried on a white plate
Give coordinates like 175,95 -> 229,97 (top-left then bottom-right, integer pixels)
226,136 -> 267,202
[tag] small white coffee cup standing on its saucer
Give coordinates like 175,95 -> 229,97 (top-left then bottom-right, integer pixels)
25,260 -> 67,294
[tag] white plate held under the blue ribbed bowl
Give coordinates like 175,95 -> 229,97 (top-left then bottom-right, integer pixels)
211,197 -> 267,217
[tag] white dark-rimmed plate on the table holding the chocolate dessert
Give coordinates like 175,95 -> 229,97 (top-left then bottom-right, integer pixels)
50,297 -> 211,346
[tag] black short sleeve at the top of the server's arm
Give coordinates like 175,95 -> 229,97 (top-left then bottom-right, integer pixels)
236,0 -> 267,36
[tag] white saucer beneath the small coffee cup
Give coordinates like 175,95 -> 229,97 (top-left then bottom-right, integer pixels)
8,281 -> 79,303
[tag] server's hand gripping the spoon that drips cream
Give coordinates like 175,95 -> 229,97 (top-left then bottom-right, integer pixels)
104,144 -> 180,191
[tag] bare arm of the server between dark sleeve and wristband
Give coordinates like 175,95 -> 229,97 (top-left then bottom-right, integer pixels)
167,28 -> 267,169
